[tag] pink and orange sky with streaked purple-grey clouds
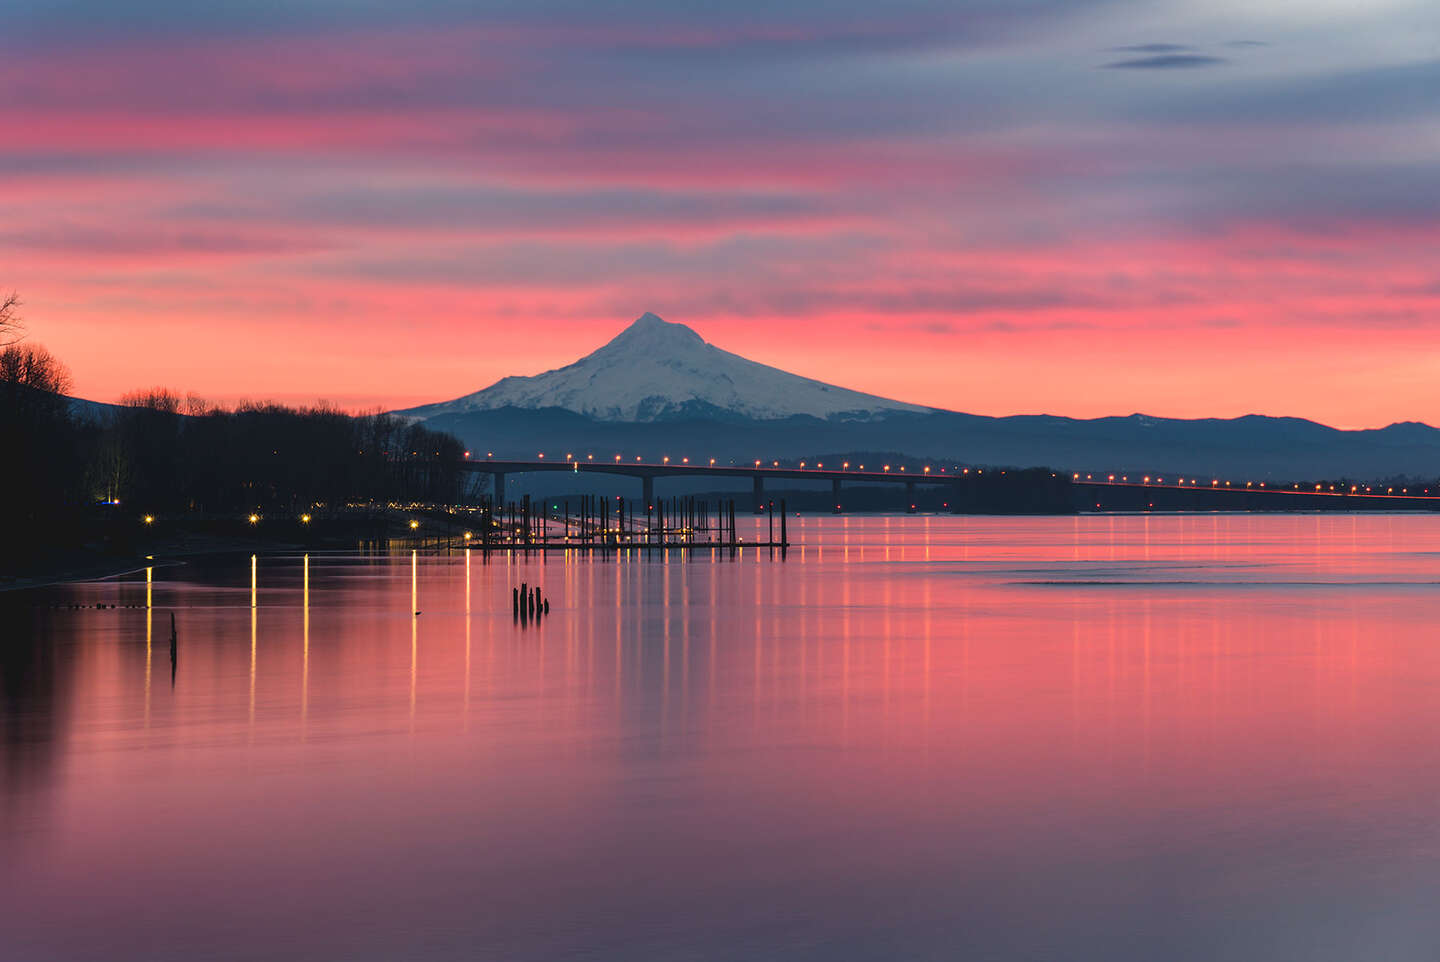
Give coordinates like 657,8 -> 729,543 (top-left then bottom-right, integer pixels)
0,0 -> 1440,428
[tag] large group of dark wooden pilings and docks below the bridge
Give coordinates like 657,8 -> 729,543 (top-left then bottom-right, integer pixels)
467,495 -> 789,550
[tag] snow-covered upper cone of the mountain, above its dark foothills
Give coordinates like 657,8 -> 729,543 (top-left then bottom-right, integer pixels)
402,313 -> 932,422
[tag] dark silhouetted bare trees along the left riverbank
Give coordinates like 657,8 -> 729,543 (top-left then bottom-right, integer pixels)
0,289 -> 471,547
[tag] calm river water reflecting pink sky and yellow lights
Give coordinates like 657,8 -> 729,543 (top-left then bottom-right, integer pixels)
0,516 -> 1440,962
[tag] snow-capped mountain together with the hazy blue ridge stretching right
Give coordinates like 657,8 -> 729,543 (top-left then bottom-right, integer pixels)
396,314 -> 1440,480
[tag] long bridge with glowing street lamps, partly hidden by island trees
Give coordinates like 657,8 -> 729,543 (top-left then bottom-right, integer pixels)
461,455 -> 1440,511
